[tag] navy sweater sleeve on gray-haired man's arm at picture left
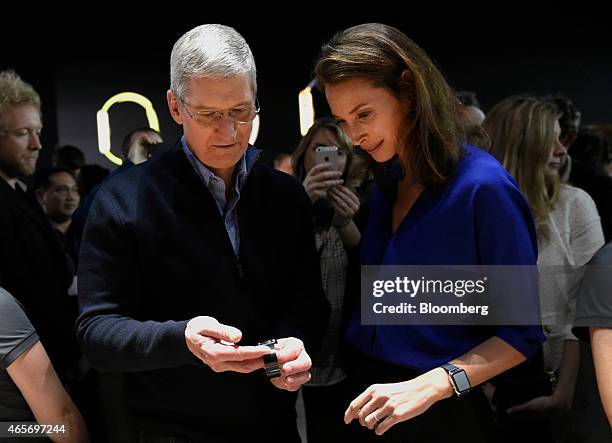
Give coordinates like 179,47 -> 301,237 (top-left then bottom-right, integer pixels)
77,189 -> 197,372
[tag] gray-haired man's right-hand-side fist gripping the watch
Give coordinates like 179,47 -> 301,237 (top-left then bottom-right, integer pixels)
270,337 -> 312,391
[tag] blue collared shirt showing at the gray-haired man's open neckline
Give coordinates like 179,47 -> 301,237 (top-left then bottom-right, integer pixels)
181,135 -> 258,255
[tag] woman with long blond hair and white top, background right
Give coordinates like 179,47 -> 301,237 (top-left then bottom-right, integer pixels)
483,96 -> 604,442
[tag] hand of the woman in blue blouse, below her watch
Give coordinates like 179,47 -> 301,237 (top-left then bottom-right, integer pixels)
344,368 -> 453,435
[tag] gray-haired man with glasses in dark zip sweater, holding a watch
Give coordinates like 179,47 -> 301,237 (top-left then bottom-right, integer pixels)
77,25 -> 329,442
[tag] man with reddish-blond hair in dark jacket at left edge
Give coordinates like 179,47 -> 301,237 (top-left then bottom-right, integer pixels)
0,71 -> 79,381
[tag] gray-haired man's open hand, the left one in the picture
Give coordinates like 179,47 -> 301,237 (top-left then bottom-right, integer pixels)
185,316 -> 272,374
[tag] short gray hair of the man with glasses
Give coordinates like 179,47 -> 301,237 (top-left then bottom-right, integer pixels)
170,25 -> 257,99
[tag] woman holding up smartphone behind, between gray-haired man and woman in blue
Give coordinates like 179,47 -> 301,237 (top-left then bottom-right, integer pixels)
293,117 -> 365,442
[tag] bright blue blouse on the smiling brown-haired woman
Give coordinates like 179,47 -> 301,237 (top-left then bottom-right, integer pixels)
347,145 -> 545,372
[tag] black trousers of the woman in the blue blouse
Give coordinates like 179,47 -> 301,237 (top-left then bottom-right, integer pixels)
342,355 -> 501,443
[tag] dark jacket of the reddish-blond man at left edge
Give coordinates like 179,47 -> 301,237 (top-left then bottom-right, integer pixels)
0,179 -> 79,381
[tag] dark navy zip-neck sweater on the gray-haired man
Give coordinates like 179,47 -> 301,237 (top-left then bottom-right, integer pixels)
77,148 -> 329,439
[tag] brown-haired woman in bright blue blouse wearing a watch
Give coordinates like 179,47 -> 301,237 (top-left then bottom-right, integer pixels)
315,24 -> 543,442
